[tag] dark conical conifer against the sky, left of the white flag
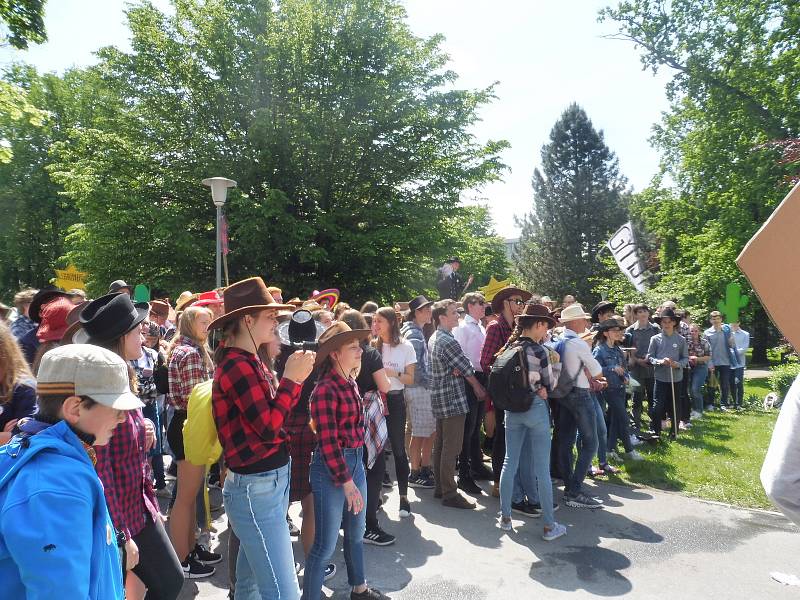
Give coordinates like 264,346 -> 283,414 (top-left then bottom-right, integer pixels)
515,104 -> 626,304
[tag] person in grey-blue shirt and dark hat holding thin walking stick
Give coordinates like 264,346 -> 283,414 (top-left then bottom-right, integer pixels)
647,308 -> 689,439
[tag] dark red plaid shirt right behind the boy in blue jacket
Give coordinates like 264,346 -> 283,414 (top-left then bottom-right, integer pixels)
94,409 -> 161,540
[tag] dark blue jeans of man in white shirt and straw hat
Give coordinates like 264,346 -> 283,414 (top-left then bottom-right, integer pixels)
558,387 -> 599,496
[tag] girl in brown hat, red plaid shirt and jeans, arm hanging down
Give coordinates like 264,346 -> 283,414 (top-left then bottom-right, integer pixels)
303,324 -> 394,600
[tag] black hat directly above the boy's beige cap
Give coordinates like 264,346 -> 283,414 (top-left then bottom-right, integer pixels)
72,293 -> 150,344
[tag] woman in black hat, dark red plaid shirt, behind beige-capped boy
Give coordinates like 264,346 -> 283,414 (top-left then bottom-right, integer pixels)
73,294 -> 183,600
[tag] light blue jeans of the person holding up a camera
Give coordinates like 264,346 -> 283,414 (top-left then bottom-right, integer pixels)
222,464 -> 300,600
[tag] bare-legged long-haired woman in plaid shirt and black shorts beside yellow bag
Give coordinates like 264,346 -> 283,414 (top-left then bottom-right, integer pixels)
167,306 -> 222,579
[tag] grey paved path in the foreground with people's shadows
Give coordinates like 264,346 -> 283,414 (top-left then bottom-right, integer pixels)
181,476 -> 800,600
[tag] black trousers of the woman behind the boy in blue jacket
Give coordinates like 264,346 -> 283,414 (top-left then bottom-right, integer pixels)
131,515 -> 183,600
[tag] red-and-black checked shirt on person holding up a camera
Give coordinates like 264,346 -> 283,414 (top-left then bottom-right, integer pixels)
211,348 -> 302,471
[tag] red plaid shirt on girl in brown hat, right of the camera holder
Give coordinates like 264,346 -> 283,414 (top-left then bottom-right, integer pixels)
311,370 -> 364,485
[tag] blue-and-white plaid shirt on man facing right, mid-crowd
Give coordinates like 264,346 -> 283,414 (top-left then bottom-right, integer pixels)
428,327 -> 475,419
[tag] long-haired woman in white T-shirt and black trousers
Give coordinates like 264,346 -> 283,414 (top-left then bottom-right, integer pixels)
372,306 -> 417,517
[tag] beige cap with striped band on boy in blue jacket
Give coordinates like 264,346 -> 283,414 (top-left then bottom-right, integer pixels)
36,344 -> 144,410
